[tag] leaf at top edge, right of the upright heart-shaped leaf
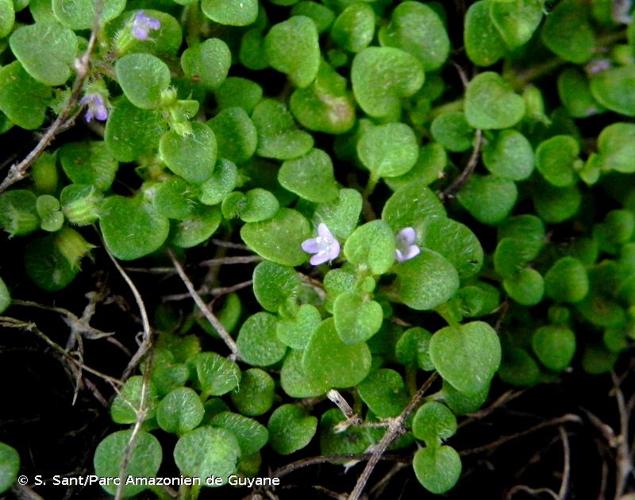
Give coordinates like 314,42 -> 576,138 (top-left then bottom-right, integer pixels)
331,2 -> 375,52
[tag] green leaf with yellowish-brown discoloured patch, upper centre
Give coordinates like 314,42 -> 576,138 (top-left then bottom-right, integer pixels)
289,61 -> 355,134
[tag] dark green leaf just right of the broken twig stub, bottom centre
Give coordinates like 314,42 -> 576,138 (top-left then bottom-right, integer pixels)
357,369 -> 409,418
